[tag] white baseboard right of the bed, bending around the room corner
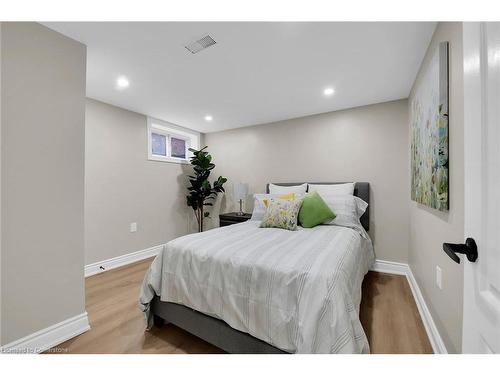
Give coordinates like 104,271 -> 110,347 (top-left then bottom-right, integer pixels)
371,259 -> 448,354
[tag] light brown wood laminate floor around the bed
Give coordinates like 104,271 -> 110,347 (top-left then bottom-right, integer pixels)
50,259 -> 432,354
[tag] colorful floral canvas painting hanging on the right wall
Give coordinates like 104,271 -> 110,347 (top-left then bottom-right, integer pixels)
410,42 -> 449,211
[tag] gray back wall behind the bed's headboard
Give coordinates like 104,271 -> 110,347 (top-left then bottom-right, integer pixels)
205,100 -> 409,263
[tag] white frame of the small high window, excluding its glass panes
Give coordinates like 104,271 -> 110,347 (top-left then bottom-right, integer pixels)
147,117 -> 200,164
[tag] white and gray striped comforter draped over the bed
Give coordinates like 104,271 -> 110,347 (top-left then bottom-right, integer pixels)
140,221 -> 374,353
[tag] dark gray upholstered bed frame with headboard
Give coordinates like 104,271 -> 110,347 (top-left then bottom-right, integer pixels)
151,182 -> 370,354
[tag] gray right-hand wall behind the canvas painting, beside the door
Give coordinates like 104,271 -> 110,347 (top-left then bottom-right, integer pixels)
409,22 -> 464,352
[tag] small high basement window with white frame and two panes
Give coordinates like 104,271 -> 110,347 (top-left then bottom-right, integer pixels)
148,118 -> 200,163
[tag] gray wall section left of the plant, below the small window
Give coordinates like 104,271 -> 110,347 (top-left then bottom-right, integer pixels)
85,99 -> 193,264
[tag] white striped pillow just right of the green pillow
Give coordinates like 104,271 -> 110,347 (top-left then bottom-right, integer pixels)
320,194 -> 368,233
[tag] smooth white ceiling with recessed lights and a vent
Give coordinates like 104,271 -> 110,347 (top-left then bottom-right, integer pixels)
45,22 -> 435,132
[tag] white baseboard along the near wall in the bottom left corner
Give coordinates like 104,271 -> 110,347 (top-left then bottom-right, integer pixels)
0,312 -> 90,354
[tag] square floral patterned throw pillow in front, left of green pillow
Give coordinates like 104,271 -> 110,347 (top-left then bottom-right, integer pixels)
260,198 -> 302,230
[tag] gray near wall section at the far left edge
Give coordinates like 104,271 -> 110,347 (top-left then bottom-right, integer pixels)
1,23 -> 86,344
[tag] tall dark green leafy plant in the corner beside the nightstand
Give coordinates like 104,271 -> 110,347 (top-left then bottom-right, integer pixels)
186,146 -> 227,232
